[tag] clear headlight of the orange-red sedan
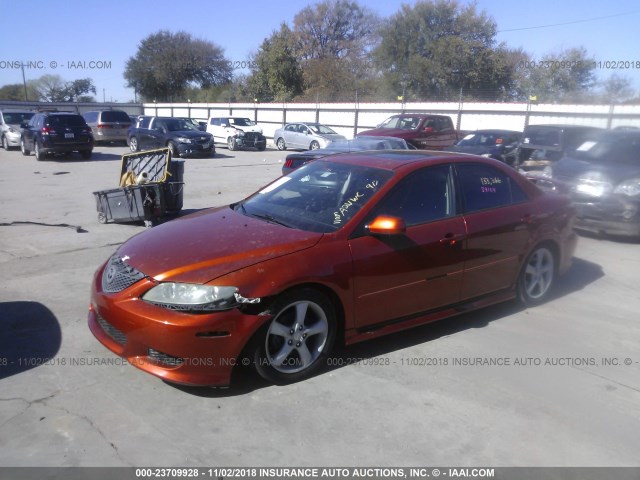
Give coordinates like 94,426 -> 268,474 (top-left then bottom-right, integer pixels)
142,282 -> 260,312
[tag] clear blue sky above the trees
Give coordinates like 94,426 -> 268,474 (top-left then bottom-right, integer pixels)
0,0 -> 640,102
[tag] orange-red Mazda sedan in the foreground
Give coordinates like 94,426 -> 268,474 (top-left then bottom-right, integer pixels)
89,151 -> 576,385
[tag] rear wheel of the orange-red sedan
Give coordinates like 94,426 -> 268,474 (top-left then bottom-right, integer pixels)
517,244 -> 556,306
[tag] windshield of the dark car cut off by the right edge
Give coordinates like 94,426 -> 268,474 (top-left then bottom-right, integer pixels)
571,134 -> 640,165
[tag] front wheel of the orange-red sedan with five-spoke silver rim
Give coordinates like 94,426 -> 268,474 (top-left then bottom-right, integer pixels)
253,288 -> 337,385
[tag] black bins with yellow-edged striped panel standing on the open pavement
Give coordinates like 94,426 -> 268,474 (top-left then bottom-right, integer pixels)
93,148 -> 184,226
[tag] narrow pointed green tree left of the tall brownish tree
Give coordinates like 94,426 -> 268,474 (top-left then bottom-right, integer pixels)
248,23 -> 304,102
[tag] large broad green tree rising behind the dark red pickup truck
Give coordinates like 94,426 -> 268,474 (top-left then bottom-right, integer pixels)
374,0 -> 514,100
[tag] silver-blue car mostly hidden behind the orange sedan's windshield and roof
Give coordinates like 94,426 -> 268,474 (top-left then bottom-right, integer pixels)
282,136 -> 416,175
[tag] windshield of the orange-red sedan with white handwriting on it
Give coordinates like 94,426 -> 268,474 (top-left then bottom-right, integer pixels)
233,161 -> 393,233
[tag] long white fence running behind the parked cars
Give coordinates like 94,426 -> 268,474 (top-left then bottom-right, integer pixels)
143,102 -> 640,138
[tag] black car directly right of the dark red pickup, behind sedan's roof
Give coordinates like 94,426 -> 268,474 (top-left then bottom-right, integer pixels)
445,130 -> 522,164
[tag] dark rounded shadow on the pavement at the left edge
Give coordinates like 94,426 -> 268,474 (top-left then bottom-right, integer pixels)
0,302 -> 62,380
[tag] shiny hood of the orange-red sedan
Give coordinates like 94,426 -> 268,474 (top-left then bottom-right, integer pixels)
118,206 -> 322,283
